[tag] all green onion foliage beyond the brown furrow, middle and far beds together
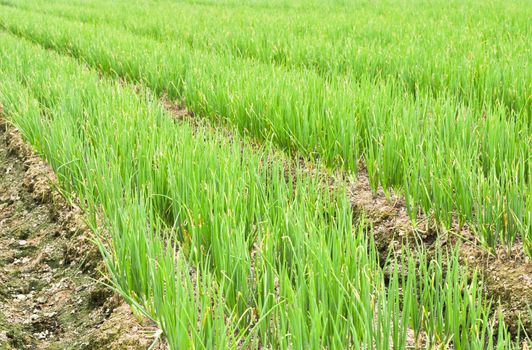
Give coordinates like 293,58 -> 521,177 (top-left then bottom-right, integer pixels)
0,1 -> 532,253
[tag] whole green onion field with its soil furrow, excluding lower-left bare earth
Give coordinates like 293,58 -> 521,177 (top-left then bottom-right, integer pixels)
0,0 -> 532,350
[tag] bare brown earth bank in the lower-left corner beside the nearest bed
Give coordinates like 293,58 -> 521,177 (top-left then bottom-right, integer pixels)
0,117 -> 162,350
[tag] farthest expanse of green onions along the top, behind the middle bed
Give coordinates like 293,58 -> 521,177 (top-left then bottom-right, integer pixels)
9,0 -> 532,115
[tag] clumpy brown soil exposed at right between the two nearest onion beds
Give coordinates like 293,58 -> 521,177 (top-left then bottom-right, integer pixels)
342,165 -> 532,335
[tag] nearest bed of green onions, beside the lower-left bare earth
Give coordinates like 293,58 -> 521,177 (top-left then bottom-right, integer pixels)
0,33 -> 517,349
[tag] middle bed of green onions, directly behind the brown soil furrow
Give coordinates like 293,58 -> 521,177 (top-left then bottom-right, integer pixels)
0,7 -> 532,254
